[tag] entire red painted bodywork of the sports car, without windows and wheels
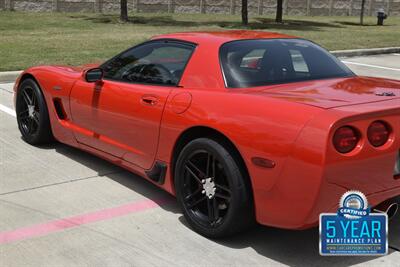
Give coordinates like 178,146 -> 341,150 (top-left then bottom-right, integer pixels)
15,31 -> 400,229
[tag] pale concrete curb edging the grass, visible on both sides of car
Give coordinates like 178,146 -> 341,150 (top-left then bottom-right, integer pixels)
0,47 -> 400,83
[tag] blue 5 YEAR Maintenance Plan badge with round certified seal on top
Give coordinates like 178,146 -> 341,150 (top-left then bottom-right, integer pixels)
319,191 -> 388,256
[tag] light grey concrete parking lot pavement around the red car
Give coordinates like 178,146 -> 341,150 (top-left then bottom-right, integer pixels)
0,54 -> 400,266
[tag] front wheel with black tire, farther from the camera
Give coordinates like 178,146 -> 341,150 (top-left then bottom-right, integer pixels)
16,79 -> 54,145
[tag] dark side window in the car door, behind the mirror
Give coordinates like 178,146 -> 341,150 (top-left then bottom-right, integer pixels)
102,41 -> 194,85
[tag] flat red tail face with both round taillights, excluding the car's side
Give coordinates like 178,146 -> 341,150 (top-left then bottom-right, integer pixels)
304,98 -> 400,229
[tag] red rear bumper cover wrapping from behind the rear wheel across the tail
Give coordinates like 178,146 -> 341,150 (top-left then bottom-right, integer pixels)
257,98 -> 400,229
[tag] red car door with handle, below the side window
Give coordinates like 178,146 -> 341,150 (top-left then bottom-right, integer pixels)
70,80 -> 171,169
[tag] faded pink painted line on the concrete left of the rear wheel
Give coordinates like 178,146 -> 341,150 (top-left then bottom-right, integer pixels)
0,198 -> 171,245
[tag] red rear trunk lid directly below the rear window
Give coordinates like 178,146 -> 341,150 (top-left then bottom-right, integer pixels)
246,76 -> 400,109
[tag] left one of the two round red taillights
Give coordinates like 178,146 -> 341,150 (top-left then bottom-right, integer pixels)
333,126 -> 360,153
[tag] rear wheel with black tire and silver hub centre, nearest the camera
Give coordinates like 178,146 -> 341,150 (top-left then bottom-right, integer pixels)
175,138 -> 254,238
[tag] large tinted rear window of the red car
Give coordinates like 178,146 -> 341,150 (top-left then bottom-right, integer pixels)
220,39 -> 354,88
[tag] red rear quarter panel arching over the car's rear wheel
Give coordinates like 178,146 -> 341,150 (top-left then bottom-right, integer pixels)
158,89 -> 321,223
